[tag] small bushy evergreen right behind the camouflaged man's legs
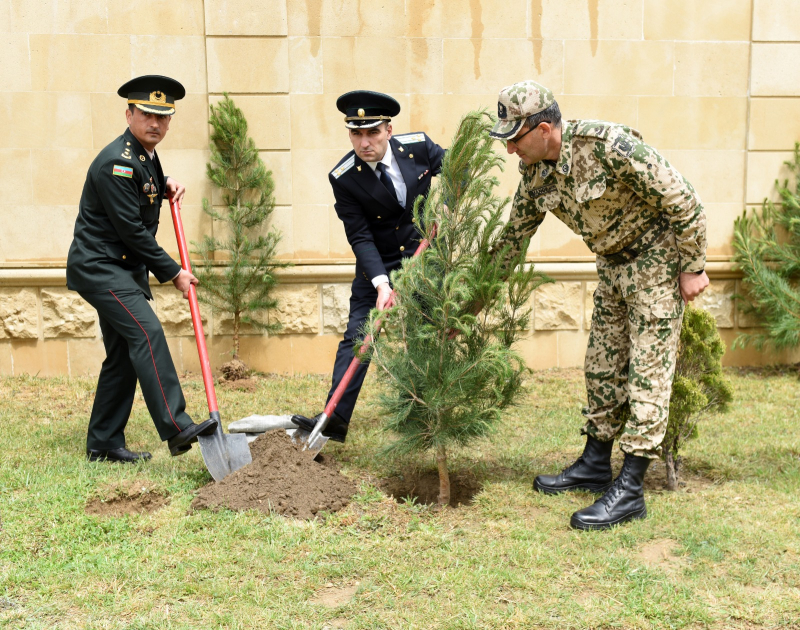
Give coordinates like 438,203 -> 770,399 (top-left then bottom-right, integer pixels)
661,306 -> 733,490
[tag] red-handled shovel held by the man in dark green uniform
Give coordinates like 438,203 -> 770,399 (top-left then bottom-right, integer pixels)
169,199 -> 253,481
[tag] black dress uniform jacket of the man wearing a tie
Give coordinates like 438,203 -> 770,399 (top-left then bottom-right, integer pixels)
328,132 -> 444,280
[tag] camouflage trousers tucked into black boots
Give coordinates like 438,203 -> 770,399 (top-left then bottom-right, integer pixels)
582,252 -> 683,458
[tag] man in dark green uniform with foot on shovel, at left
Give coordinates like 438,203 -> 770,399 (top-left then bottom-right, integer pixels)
67,75 -> 217,462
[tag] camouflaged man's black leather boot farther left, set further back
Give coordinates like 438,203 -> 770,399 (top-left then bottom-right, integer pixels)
533,435 -> 614,494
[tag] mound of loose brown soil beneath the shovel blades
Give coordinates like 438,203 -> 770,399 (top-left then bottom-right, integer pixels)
192,430 -> 356,519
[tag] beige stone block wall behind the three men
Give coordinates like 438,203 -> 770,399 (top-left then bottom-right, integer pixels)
0,0 -> 800,374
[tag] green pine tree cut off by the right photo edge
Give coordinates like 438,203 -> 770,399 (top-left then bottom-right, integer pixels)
733,143 -> 800,350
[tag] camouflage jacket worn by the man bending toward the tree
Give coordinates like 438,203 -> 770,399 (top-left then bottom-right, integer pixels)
494,120 -> 706,272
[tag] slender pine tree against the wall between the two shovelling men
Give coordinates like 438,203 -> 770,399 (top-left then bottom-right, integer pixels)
192,94 -> 288,360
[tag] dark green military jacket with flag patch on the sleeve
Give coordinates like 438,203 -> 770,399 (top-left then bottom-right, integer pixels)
67,129 -> 181,298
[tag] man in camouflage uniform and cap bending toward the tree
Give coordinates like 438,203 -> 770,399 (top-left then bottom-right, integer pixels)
491,81 -> 708,529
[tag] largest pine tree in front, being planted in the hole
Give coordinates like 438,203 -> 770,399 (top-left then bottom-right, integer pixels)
368,111 -> 547,505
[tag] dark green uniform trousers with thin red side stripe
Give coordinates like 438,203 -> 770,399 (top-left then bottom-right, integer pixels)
80,290 -> 192,450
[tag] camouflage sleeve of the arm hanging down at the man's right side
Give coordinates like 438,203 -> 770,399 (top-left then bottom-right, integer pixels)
605,130 -> 706,273
